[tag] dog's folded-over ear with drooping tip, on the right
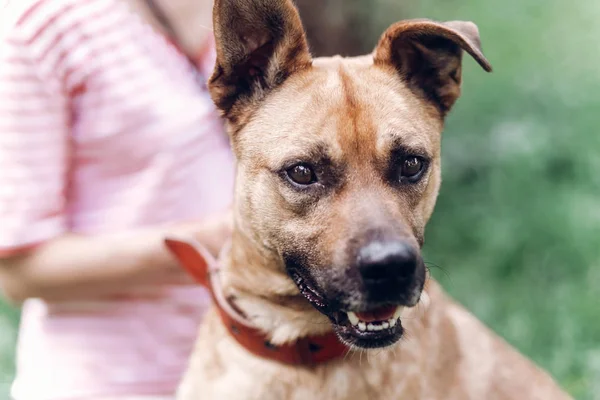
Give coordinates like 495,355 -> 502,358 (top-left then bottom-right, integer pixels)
374,20 -> 492,116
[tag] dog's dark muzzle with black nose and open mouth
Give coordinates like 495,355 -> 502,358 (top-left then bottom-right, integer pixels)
287,240 -> 426,348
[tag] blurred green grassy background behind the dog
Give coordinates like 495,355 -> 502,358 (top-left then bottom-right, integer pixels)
0,0 -> 600,400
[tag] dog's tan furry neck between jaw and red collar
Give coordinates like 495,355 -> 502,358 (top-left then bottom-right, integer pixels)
220,229 -> 332,345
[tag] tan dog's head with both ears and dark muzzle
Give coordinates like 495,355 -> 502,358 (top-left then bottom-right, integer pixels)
209,0 -> 491,348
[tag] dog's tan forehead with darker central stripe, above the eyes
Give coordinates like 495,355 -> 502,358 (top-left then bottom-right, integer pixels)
241,56 -> 442,163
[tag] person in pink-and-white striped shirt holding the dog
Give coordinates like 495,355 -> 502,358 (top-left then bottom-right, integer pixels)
0,0 -> 234,400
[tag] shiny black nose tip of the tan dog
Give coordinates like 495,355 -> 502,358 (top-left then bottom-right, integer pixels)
358,241 -> 418,285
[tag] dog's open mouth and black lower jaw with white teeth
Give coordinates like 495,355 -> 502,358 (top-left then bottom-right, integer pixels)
292,274 -> 404,349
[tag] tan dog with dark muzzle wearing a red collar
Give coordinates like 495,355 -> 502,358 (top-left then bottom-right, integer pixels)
167,0 -> 570,400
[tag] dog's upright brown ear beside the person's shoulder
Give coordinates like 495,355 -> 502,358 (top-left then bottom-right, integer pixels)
209,0 -> 312,122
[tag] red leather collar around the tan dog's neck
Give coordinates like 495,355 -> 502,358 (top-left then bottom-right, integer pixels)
165,238 -> 348,365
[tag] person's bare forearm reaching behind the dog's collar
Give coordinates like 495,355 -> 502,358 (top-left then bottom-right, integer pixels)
0,213 -> 231,303
